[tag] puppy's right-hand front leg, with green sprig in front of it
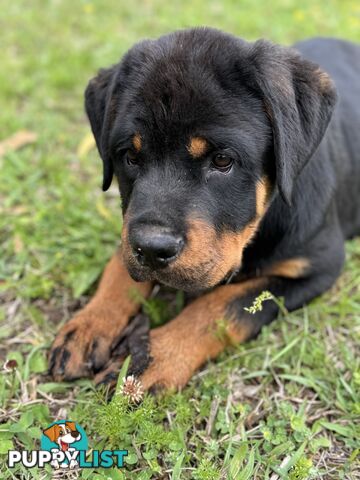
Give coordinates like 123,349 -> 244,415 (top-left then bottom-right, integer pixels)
98,262 -> 337,390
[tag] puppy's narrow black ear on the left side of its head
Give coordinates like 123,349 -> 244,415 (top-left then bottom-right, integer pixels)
85,66 -> 116,191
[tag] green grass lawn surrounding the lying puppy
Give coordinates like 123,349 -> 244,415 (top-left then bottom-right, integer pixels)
0,0 -> 360,480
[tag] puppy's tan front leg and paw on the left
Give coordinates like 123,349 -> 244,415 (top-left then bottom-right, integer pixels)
50,249 -> 152,380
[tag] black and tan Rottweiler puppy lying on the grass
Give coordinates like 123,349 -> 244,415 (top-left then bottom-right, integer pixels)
50,28 -> 360,388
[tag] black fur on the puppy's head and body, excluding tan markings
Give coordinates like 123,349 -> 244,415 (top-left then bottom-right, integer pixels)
86,28 -> 360,333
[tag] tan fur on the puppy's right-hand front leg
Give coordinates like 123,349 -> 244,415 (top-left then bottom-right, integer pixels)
141,278 -> 266,389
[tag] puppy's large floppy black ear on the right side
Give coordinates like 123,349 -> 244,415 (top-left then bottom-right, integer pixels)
250,40 -> 337,204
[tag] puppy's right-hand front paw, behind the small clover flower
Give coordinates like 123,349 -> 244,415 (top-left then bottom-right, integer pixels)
95,315 -> 210,392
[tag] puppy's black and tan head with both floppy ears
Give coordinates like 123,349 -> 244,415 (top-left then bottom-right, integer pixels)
85,28 -> 336,289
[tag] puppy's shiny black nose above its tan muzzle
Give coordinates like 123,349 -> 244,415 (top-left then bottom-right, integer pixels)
130,226 -> 184,268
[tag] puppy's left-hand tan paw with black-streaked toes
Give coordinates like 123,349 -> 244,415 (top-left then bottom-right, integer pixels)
49,307 -> 127,381
